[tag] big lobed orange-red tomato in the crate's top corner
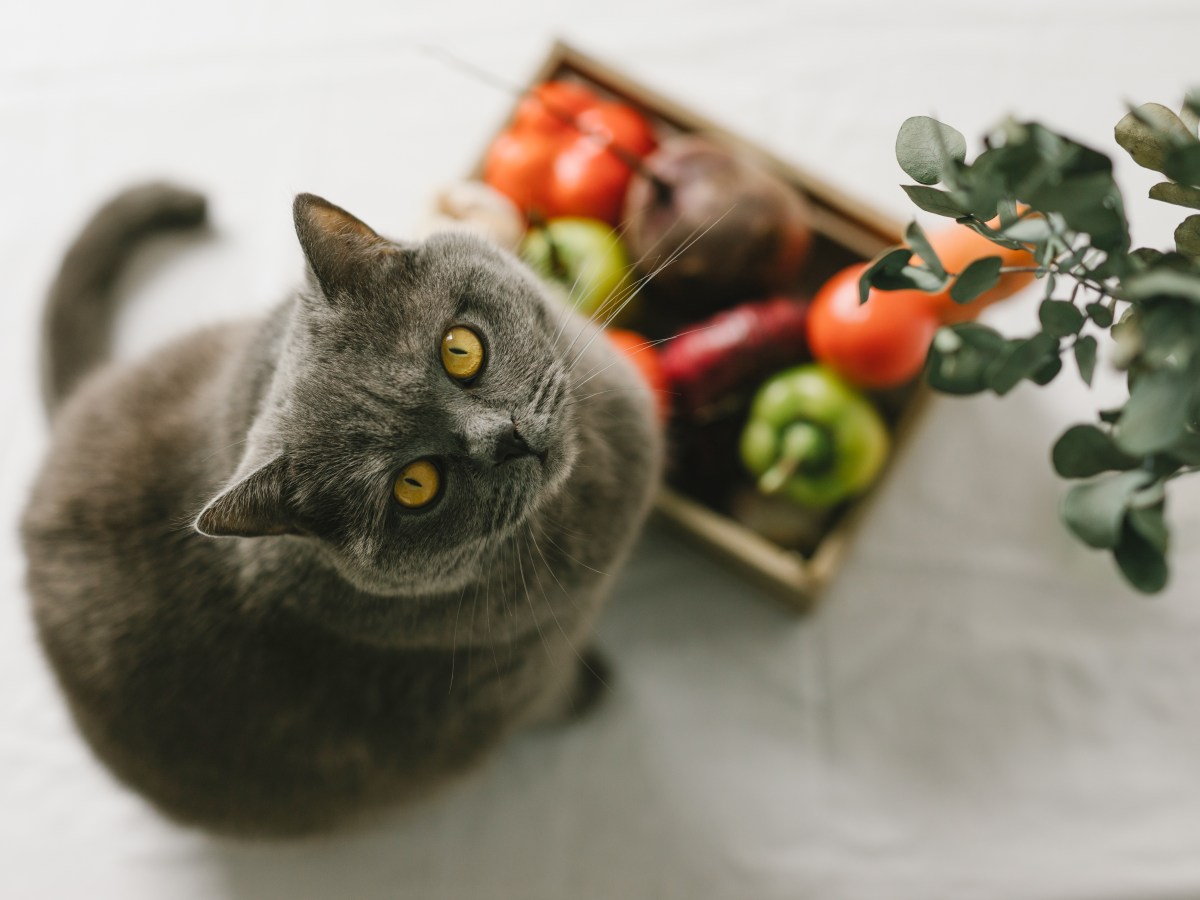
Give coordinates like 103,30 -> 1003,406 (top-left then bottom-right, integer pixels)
484,82 -> 656,224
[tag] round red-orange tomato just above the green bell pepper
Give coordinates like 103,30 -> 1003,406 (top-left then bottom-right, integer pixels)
808,263 -> 938,388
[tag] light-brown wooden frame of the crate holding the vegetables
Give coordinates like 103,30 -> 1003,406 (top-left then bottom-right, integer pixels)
474,42 -> 928,611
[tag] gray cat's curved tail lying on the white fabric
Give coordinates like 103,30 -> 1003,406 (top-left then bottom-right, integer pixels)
42,184 -> 206,415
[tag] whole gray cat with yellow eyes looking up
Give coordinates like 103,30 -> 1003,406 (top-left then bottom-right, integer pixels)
23,185 -> 661,835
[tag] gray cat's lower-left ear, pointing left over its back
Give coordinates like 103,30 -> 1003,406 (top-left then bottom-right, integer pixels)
196,456 -> 302,538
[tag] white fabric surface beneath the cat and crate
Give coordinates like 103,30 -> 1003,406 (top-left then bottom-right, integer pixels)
0,0 -> 1200,900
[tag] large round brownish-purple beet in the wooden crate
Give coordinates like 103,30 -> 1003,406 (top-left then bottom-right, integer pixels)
624,134 -> 812,310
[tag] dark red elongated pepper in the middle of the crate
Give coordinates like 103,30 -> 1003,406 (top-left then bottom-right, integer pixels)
660,296 -> 808,413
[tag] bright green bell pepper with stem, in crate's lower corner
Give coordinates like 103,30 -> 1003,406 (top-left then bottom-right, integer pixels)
740,364 -> 890,509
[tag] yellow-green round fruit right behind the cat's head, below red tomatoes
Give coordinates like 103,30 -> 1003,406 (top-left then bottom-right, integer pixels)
521,216 -> 637,325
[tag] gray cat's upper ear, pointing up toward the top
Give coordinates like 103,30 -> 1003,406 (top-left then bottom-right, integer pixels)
292,193 -> 400,304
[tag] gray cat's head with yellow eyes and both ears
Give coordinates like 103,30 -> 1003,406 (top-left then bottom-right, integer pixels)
197,194 -> 577,594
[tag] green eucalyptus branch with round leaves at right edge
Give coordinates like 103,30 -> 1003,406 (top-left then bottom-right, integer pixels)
862,101 -> 1200,593
